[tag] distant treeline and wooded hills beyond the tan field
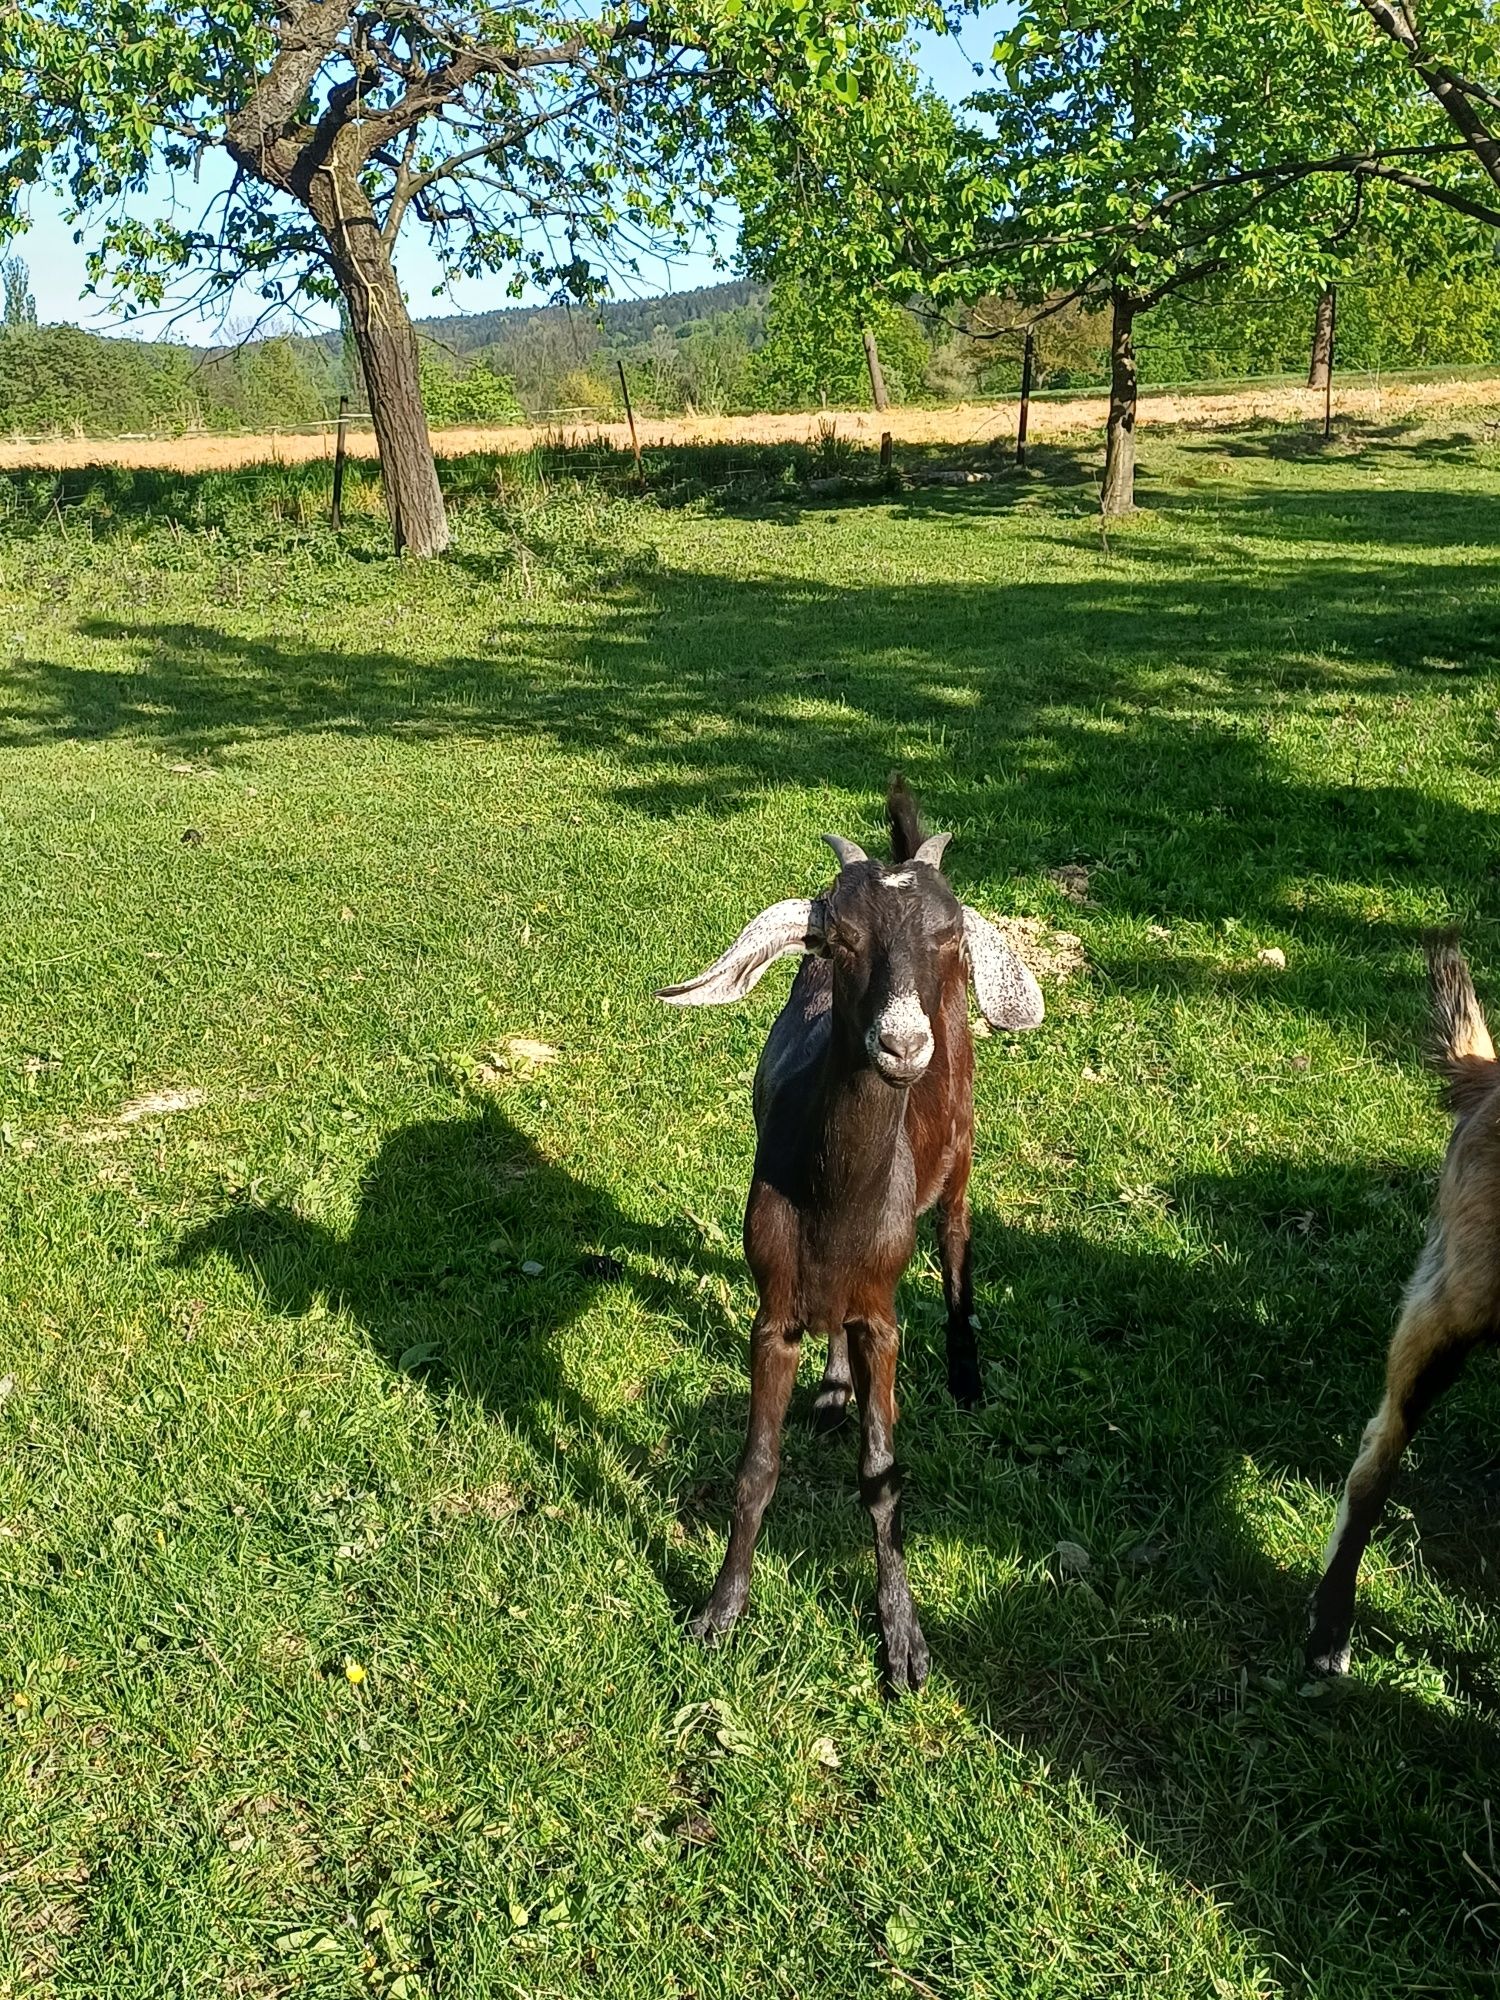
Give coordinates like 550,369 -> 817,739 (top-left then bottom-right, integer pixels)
0,260 -> 1500,436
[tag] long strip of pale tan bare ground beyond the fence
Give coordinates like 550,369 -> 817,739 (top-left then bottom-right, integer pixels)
11,378 -> 1500,472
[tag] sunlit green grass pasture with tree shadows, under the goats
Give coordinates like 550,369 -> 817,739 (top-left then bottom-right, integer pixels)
0,420 -> 1500,2000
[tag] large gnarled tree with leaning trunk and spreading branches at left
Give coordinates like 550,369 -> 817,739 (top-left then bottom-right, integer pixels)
20,0 -> 916,556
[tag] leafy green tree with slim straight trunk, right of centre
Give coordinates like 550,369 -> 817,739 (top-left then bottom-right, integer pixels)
952,0 -> 1456,514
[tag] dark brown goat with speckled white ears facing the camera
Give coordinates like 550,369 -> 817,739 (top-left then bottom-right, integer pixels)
658,776 -> 1042,1690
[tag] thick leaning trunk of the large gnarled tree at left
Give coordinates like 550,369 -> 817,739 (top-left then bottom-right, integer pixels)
308,170 -> 448,556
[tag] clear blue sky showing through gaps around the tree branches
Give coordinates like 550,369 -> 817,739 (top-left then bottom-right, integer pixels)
12,8 -> 1010,340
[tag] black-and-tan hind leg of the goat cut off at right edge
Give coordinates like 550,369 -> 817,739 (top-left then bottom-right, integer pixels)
1306,1286 -> 1482,1674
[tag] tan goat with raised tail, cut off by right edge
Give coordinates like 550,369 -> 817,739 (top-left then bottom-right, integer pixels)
1306,932 -> 1500,1674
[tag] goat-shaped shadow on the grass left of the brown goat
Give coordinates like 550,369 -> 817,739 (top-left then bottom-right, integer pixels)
176,1100 -> 764,1608
